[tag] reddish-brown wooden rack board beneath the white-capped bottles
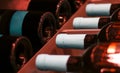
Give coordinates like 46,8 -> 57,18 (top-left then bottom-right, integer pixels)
18,0 -> 120,73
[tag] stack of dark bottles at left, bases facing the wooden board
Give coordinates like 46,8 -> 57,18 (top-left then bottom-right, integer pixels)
0,0 -> 84,73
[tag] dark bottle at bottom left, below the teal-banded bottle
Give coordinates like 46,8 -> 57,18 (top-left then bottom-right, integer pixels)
0,35 -> 33,73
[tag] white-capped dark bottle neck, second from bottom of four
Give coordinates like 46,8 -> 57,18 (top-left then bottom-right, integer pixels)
56,33 -> 97,49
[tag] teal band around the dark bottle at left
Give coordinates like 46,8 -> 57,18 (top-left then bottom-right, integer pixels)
9,11 -> 28,36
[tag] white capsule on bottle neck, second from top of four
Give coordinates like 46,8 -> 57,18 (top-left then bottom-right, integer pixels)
73,17 -> 100,29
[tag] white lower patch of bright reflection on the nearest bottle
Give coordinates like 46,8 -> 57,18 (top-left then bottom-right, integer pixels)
107,53 -> 120,67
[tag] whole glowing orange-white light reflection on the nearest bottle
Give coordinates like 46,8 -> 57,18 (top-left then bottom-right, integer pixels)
107,43 -> 120,67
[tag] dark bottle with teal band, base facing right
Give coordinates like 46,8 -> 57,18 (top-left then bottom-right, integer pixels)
0,11 -> 56,52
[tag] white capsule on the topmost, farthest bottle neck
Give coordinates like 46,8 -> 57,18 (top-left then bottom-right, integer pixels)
86,3 -> 111,16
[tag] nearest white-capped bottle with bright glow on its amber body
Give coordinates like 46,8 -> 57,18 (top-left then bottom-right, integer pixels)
35,42 -> 120,73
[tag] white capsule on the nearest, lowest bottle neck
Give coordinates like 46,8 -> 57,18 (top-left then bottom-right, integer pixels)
35,54 -> 70,71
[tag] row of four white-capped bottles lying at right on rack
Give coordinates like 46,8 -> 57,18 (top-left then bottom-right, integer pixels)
36,3 -> 120,73
